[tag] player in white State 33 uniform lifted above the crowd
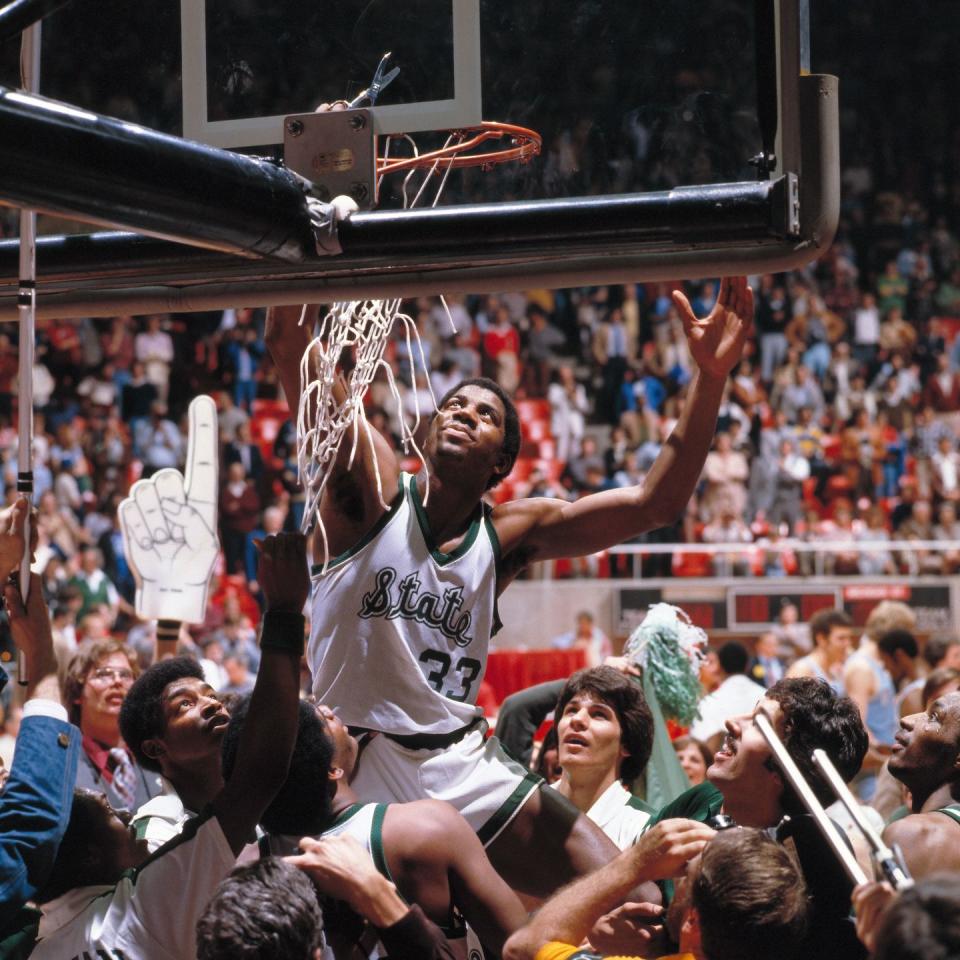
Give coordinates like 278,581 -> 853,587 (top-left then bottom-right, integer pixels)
266,278 -> 753,896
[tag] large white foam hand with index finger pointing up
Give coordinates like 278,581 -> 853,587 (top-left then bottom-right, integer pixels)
119,396 -> 220,623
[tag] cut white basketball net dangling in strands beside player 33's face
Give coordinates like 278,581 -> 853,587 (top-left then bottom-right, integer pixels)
297,134 -> 468,570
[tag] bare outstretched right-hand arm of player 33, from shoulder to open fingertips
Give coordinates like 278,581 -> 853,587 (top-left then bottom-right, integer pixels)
494,277 -> 753,562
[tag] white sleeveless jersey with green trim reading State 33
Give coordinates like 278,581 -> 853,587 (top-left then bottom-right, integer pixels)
307,473 -> 500,735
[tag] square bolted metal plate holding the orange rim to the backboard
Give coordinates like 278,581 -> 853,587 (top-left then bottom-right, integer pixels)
283,109 -> 377,210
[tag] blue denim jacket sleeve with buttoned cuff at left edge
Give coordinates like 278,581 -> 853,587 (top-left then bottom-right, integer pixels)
0,668 -> 80,931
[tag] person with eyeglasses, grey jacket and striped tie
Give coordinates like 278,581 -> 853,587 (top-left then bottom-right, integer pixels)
63,638 -> 163,812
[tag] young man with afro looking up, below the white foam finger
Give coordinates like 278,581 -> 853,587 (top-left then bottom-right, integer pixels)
120,656 -> 230,853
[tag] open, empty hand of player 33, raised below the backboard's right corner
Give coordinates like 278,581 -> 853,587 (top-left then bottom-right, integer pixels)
673,277 -> 753,378
